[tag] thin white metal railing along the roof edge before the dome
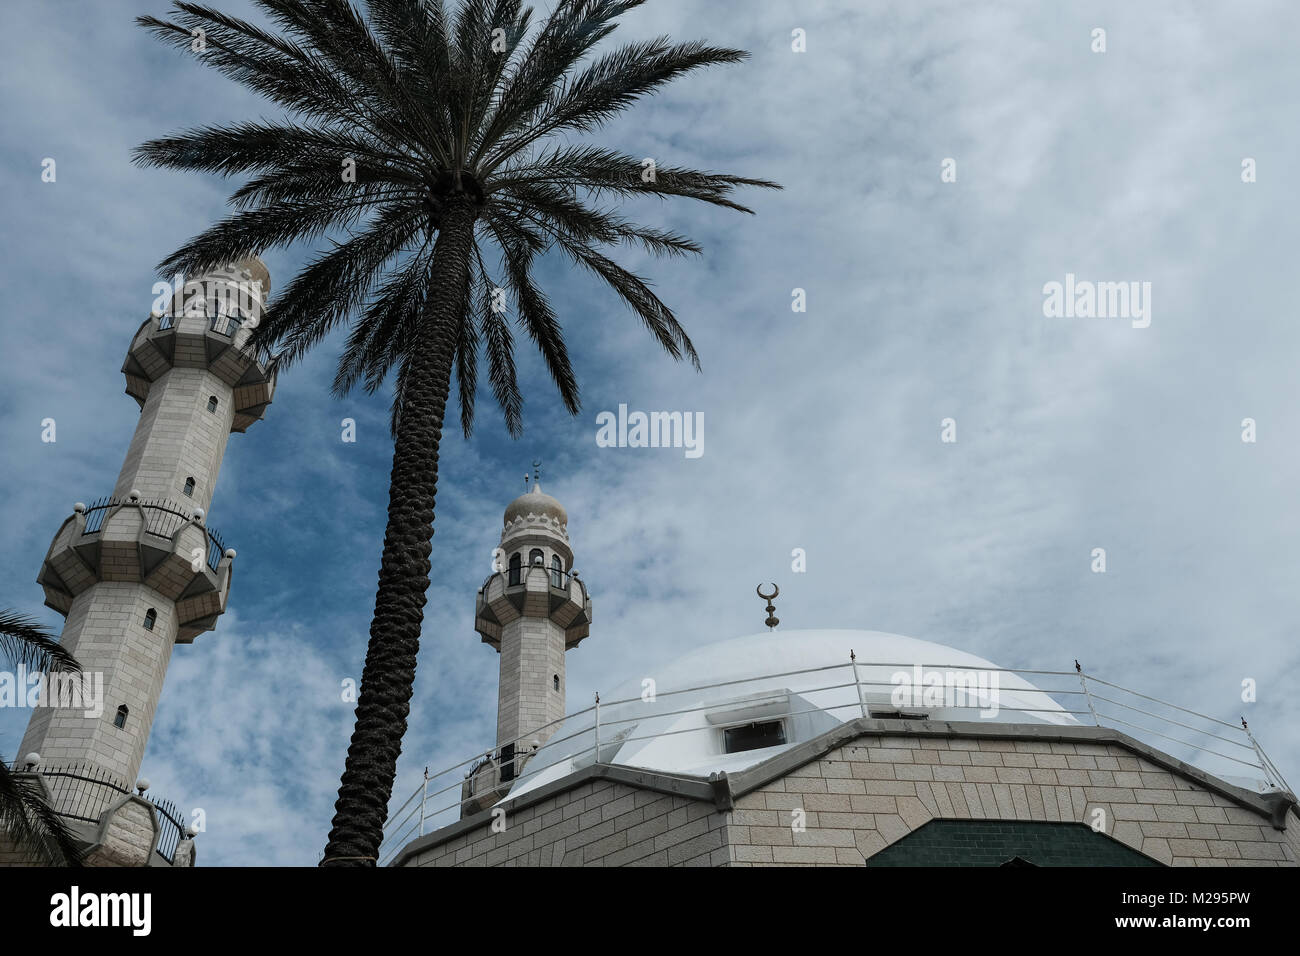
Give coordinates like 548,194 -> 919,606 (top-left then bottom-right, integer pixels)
378,658 -> 1294,866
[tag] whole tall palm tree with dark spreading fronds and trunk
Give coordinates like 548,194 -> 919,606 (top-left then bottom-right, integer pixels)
135,0 -> 776,865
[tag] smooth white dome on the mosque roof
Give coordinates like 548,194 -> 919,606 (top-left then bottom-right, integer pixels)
510,630 -> 1078,797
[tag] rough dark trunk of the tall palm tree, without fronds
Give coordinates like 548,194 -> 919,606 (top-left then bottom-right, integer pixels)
321,194 -> 476,866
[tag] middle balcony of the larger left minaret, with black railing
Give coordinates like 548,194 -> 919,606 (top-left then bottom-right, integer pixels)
36,496 -> 235,644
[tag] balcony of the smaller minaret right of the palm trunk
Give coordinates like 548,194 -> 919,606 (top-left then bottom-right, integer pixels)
475,564 -> 592,650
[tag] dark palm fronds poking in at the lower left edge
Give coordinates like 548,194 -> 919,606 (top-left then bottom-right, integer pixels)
0,610 -> 83,866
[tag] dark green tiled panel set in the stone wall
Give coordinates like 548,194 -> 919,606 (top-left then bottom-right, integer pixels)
867,819 -> 1162,866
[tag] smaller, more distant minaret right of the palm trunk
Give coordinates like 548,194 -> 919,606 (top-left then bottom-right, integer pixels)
475,481 -> 592,782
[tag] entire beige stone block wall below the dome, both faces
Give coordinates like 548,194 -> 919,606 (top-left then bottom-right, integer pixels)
398,728 -> 1300,866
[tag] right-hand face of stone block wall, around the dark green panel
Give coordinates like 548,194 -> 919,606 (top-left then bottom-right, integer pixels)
728,736 -> 1300,866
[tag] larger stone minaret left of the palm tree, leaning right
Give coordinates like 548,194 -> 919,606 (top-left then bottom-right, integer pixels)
18,258 -> 276,816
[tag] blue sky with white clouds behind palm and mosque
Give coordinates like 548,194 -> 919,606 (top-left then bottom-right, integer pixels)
0,0 -> 1300,865
